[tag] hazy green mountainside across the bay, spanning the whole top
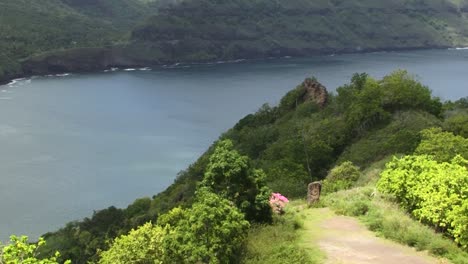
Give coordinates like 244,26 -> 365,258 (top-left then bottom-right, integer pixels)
0,0 -> 468,81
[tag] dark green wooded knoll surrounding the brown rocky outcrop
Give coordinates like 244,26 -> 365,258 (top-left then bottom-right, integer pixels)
224,71 -> 442,197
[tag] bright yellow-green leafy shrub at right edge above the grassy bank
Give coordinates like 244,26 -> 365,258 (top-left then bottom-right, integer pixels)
377,156 -> 468,248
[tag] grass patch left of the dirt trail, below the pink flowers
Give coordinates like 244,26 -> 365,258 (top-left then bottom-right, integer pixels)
242,202 -> 322,264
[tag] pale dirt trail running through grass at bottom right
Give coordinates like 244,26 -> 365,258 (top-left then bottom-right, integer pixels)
302,208 -> 446,264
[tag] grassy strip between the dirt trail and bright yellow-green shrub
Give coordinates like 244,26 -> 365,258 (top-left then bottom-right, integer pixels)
322,188 -> 468,264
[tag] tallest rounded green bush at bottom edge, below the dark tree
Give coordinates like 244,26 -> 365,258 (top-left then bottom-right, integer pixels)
158,188 -> 249,264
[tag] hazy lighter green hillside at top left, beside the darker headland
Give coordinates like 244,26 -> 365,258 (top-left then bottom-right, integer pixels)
0,0 -> 155,81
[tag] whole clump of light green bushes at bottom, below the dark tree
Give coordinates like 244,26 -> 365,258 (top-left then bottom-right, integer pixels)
100,188 -> 250,264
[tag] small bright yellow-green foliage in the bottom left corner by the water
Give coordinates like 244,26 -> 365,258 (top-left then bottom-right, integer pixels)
0,235 -> 71,264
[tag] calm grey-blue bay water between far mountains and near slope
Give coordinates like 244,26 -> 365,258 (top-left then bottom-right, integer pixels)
0,50 -> 468,241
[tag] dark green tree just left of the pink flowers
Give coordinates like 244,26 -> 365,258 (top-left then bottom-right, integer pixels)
202,140 -> 272,222
